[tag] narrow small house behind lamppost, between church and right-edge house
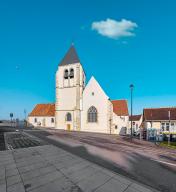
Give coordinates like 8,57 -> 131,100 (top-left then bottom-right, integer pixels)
128,115 -> 142,135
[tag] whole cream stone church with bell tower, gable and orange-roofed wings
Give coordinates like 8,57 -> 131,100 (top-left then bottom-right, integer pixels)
28,45 -> 129,134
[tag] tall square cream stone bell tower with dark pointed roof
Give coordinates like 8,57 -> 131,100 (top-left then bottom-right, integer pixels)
55,45 -> 86,131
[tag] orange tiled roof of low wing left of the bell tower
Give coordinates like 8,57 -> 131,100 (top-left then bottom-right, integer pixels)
29,104 -> 55,116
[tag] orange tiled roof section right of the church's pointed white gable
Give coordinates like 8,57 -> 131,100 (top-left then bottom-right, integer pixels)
111,100 -> 128,116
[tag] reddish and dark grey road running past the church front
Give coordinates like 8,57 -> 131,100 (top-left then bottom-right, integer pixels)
28,130 -> 176,192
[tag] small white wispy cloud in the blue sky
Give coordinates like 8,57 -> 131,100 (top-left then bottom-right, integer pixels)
92,18 -> 138,39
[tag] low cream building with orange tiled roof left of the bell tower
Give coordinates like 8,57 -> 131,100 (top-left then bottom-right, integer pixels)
28,104 -> 55,127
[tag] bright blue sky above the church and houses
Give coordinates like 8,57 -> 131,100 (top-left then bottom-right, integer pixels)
0,0 -> 176,119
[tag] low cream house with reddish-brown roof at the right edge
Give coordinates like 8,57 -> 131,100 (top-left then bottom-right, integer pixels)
143,107 -> 176,140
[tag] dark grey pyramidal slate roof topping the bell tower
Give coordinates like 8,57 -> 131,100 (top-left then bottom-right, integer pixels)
59,45 -> 80,66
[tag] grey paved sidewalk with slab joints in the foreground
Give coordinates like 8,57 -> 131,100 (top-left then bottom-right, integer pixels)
0,145 -> 159,192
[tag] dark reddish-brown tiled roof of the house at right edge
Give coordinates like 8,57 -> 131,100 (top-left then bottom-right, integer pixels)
143,107 -> 176,120
